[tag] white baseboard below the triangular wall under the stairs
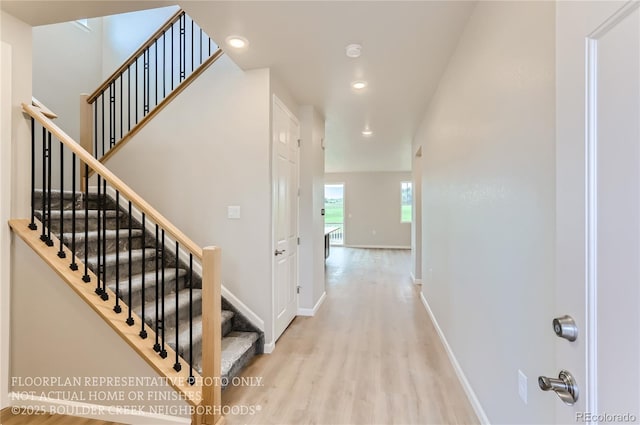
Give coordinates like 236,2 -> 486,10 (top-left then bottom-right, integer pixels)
9,392 -> 191,425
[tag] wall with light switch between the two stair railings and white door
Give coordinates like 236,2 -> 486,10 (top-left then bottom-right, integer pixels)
106,56 -> 273,342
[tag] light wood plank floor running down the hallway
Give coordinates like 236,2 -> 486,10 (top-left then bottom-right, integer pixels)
222,247 -> 478,424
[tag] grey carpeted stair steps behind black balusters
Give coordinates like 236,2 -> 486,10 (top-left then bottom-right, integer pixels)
34,190 -> 264,388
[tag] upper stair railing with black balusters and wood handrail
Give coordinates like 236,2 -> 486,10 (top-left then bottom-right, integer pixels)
85,10 -> 222,162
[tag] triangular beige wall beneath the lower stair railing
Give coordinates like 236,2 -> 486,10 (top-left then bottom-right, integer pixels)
10,236 -> 188,416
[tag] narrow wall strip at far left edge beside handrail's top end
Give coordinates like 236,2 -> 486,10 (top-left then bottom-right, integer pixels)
0,12 -> 32,408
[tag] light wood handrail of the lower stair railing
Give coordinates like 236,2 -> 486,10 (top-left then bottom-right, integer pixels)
22,103 -> 202,261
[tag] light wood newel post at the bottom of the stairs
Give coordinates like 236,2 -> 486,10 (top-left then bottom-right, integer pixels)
194,247 -> 224,425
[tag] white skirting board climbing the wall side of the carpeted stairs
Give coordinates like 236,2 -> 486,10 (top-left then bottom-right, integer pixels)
100,186 -> 264,332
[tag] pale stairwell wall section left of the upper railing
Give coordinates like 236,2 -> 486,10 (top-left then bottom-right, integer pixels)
33,18 -> 102,142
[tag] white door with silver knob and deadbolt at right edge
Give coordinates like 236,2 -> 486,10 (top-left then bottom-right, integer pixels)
549,2 -> 640,424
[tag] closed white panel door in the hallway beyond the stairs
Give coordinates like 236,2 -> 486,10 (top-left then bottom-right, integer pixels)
273,96 -> 300,339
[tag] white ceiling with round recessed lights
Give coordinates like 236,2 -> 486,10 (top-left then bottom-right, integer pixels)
1,0 -> 474,172
